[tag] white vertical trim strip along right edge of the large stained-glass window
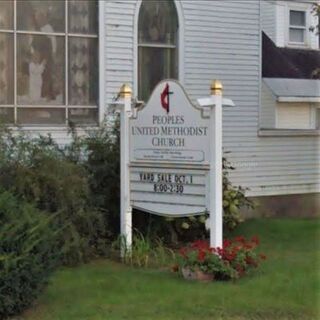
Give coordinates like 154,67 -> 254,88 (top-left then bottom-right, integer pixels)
98,1 -> 107,123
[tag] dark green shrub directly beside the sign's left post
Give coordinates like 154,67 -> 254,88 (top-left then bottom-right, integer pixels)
65,118 -> 120,240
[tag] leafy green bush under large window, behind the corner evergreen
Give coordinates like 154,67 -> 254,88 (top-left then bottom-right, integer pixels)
0,130 -> 107,264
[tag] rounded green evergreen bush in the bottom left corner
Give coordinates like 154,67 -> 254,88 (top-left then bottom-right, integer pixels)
0,192 -> 60,319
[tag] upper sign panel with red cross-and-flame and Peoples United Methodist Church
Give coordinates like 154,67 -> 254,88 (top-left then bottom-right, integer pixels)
130,80 -> 210,164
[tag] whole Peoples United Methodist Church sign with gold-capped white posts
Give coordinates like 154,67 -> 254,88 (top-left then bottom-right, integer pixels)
112,80 -> 234,257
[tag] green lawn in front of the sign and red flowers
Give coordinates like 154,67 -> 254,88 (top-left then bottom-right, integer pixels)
22,219 -> 320,320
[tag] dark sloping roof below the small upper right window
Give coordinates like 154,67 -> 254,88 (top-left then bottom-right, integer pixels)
262,32 -> 320,79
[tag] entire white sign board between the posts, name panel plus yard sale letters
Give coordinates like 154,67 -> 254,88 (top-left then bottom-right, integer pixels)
129,80 -> 210,216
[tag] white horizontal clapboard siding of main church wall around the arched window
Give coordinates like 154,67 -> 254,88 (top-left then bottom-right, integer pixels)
104,0 -> 320,195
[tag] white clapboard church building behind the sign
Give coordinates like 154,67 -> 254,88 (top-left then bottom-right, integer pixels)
0,0 -> 320,215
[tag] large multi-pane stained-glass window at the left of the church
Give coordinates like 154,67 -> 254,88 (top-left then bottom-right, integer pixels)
0,0 -> 98,125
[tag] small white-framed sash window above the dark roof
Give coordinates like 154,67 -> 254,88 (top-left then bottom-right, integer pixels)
289,10 -> 306,44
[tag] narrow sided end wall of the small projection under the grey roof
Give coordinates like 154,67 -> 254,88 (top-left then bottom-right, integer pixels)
260,81 -> 276,128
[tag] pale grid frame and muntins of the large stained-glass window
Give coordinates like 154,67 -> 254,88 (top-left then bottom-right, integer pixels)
0,0 -> 105,130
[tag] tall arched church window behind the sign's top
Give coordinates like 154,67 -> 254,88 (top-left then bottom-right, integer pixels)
138,0 -> 179,101
